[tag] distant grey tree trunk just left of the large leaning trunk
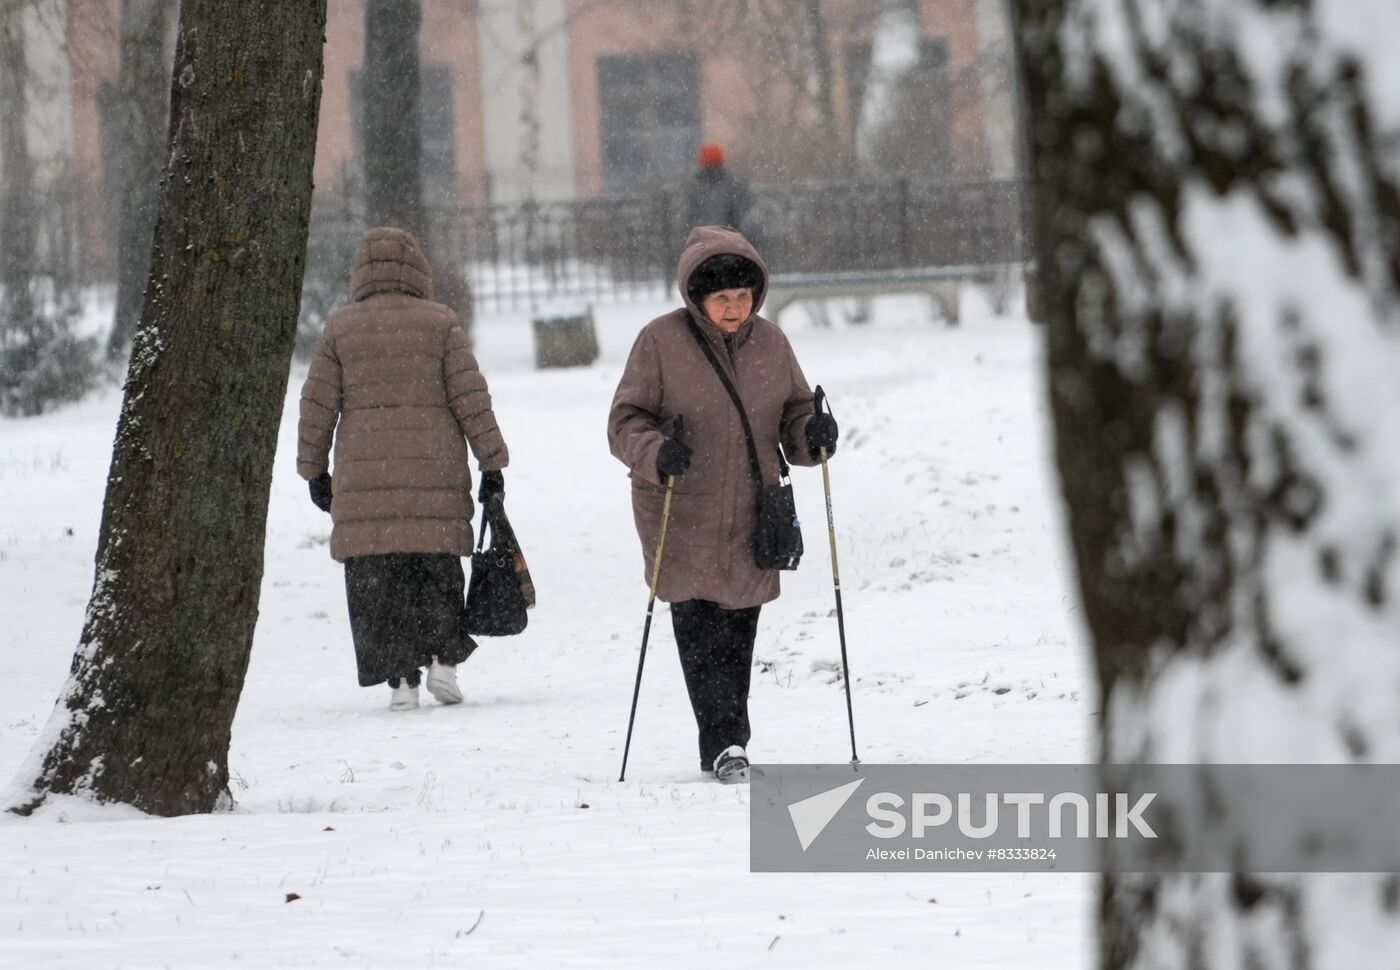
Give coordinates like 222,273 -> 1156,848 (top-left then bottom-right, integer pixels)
106,0 -> 174,358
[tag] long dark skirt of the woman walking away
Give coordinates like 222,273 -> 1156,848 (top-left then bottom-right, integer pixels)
346,553 -> 476,687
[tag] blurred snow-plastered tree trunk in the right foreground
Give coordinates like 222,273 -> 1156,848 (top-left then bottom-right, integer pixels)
1016,0 -> 1400,970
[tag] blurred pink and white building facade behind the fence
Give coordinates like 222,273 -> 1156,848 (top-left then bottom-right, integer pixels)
57,0 -> 1014,266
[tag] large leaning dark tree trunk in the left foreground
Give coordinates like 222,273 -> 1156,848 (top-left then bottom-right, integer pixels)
11,0 -> 326,815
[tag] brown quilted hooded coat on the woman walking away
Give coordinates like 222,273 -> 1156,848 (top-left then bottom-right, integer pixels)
297,228 -> 510,561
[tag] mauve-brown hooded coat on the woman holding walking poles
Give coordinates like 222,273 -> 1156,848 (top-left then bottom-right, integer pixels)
608,225 -> 818,609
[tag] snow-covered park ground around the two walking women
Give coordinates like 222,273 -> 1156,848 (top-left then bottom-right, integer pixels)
0,294 -> 1095,969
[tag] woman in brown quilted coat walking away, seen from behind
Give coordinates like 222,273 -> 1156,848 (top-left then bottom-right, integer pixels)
297,228 -> 510,711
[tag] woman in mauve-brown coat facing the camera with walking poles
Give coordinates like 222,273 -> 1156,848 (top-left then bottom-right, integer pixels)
608,225 -> 837,781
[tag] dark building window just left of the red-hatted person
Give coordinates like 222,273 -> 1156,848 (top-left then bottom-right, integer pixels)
598,50 -> 700,193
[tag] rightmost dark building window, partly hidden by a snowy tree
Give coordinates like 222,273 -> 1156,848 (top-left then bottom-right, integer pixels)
846,38 -> 953,178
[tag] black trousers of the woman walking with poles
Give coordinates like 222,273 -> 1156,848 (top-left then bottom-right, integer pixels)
671,599 -> 762,771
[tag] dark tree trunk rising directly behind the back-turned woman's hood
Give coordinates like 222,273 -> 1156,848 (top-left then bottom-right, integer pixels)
364,0 -> 427,239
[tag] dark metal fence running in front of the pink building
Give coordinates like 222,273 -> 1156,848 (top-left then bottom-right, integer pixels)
308,179 -> 1023,309
